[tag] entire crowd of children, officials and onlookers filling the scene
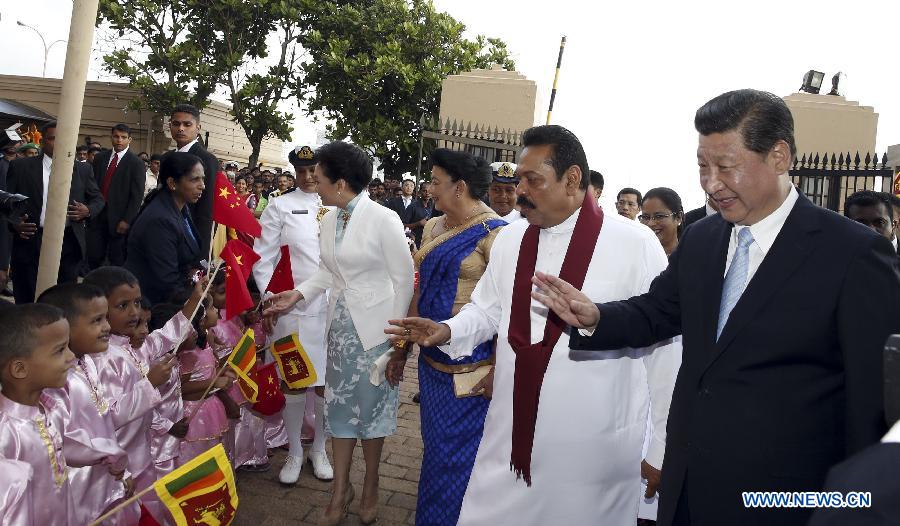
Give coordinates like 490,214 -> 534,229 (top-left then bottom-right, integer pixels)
0,90 -> 900,526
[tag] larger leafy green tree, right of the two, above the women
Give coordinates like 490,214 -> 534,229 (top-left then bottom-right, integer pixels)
299,0 -> 515,177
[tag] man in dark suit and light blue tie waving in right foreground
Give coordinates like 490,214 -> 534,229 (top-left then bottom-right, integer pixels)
535,90 -> 900,526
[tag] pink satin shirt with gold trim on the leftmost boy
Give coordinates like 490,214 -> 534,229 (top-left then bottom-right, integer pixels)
0,393 -> 124,526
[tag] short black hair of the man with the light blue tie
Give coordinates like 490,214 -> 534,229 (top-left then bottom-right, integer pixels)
694,89 -> 797,159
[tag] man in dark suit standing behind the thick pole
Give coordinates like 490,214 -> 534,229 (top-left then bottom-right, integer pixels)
6,122 -> 103,303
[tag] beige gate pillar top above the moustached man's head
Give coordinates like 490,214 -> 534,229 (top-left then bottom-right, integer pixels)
440,66 -> 537,132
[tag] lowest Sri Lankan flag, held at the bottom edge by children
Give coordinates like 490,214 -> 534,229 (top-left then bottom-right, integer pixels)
154,444 -> 238,526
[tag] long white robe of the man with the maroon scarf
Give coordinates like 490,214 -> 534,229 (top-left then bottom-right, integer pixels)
444,208 -> 681,525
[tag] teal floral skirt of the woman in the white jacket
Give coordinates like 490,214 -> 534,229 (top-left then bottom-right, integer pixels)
325,294 -> 399,440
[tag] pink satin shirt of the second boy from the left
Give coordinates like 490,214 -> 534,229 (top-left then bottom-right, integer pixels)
50,357 -> 141,525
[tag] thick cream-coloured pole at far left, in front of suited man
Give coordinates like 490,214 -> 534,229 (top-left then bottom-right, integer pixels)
35,0 -> 99,296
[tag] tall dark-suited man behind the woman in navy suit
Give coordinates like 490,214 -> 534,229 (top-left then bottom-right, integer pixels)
169,104 -> 219,259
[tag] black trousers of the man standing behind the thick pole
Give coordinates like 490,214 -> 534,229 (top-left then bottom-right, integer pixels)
10,228 -> 84,304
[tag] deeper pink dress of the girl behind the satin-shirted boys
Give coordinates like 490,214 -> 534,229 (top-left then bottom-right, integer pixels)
178,347 -> 228,466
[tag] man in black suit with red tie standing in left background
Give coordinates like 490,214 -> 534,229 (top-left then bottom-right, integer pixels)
87,124 -> 147,269
